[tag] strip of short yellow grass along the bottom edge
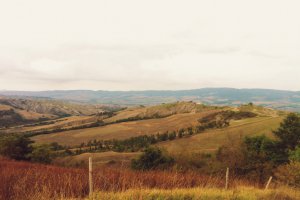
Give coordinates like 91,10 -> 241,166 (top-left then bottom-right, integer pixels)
89,187 -> 300,200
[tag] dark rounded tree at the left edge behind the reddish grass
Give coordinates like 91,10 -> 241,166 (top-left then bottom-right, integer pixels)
0,135 -> 33,160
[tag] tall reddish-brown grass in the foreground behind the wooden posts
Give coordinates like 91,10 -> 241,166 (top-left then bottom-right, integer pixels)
0,158 -> 255,200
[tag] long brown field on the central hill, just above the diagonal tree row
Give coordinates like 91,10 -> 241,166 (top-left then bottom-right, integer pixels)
32,110 -> 217,145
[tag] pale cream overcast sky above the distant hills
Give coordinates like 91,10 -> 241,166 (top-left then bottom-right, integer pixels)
0,0 -> 300,91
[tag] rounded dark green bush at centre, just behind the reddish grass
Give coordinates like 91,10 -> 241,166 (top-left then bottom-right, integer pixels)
131,147 -> 174,170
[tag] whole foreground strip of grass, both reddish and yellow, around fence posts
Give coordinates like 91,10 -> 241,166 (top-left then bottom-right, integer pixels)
0,158 -> 300,200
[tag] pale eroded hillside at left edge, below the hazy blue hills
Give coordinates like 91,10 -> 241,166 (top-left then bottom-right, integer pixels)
0,97 -> 112,128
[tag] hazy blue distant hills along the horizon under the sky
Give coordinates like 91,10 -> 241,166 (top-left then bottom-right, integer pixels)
0,88 -> 300,111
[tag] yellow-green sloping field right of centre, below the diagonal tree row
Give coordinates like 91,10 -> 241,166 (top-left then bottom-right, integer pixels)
158,117 -> 283,154
